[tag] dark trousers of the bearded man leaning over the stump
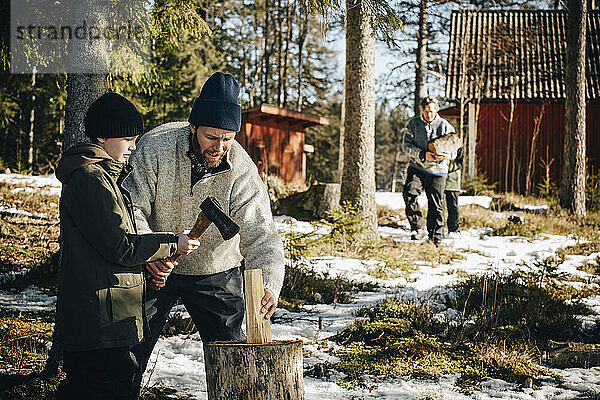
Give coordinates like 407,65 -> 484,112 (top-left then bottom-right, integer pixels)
132,268 -> 244,396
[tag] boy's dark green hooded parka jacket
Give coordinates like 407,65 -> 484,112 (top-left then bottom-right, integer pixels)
56,144 -> 177,351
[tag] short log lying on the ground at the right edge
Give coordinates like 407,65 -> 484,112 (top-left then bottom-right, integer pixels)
548,340 -> 600,368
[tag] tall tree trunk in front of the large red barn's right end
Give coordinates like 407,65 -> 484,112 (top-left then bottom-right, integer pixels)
560,0 -> 587,216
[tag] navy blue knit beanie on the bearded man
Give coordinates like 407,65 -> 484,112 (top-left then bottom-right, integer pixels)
188,72 -> 242,132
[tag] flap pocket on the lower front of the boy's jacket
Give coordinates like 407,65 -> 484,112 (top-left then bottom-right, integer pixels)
110,273 -> 144,323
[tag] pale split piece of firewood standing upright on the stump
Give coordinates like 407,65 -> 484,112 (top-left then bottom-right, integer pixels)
244,268 -> 273,343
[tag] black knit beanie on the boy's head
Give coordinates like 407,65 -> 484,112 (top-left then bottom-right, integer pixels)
83,93 -> 144,139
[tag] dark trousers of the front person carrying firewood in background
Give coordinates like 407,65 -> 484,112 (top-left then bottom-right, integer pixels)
402,167 -> 446,239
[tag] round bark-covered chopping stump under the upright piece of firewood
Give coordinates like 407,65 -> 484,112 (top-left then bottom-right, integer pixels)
204,340 -> 304,400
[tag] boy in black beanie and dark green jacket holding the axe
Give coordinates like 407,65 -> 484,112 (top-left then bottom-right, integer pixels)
56,93 -> 199,400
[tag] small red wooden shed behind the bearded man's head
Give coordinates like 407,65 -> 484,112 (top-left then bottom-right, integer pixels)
235,104 -> 329,184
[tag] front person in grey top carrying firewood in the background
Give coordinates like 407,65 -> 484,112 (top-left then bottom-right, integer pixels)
402,96 -> 456,246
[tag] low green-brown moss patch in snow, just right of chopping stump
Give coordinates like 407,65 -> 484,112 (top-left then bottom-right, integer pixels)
334,292 -> 560,392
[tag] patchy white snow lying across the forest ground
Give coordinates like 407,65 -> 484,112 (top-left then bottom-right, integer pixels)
0,174 -> 600,400
